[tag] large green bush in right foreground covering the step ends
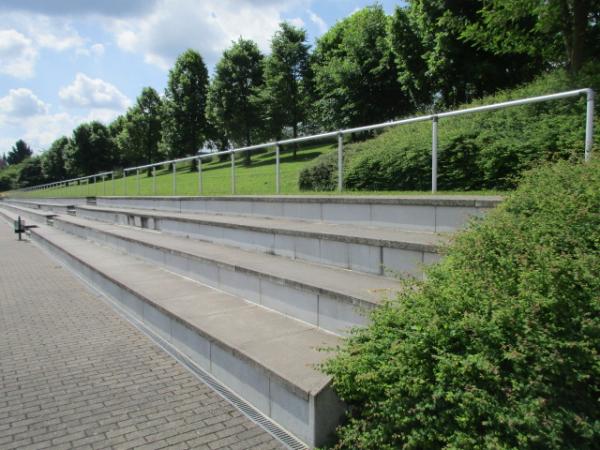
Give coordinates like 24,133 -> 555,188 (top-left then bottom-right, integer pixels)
324,160 -> 600,449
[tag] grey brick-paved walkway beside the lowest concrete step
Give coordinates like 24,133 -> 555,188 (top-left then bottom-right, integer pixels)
0,225 -> 283,450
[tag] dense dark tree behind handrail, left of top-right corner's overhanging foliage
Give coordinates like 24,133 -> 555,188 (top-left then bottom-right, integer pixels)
390,0 -> 543,107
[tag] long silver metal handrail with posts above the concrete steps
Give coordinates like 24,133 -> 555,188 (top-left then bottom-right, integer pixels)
15,88 -> 594,194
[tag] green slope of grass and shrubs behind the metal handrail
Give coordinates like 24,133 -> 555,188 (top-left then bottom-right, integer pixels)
11,63 -> 600,196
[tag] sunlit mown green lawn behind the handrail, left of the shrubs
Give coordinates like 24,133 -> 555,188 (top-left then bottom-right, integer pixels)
11,144 -> 500,197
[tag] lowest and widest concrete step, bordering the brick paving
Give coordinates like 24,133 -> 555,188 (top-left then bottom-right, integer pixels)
0,207 -> 344,447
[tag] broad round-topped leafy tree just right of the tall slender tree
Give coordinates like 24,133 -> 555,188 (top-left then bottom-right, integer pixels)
311,5 -> 410,128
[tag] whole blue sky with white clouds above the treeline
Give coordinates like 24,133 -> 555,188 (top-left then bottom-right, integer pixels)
0,0 -> 401,153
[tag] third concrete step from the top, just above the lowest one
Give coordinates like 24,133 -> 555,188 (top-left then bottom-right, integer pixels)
53,216 -> 401,334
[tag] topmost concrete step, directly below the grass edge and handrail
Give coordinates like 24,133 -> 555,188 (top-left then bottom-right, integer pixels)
91,195 -> 502,232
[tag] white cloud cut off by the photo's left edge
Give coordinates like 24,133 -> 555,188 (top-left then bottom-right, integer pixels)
0,29 -> 37,78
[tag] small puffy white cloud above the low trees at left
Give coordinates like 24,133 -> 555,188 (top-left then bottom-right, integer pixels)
58,73 -> 131,111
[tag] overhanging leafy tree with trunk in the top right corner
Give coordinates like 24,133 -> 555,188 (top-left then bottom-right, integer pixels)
463,0 -> 600,72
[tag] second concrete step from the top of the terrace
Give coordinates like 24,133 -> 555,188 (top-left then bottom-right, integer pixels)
76,206 -> 447,278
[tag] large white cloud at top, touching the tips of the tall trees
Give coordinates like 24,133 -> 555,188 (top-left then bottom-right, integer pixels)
108,0 -> 300,70
